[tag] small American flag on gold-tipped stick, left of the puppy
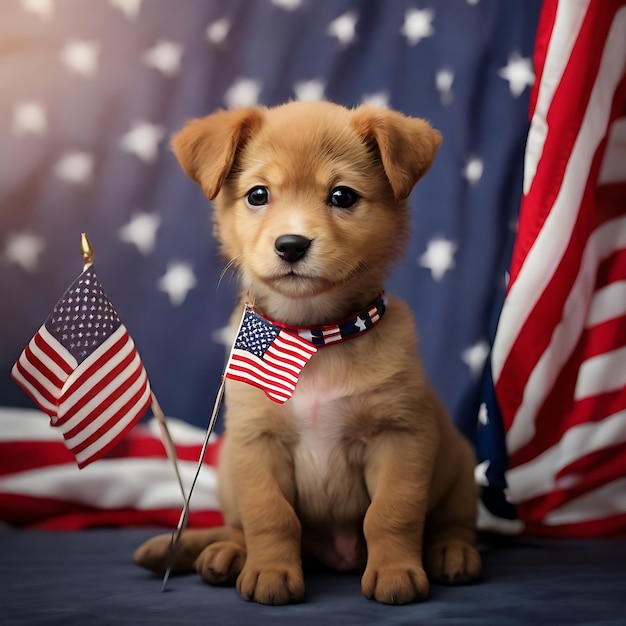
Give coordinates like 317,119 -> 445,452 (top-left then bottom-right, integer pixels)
11,266 -> 151,468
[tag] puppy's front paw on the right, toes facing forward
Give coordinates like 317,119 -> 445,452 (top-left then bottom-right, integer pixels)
361,565 -> 429,604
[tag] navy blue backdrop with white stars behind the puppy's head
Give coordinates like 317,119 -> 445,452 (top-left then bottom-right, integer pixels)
0,0 -> 541,442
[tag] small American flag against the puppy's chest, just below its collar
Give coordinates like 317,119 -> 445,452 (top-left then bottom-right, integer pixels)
226,306 -> 317,404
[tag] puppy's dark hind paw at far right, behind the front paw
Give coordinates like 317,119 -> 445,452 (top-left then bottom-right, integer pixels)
426,541 -> 482,585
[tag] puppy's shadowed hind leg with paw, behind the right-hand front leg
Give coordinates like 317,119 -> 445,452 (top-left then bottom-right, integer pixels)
424,446 -> 481,585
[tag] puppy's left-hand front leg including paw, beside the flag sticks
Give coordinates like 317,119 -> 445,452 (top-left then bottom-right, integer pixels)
232,435 -> 304,604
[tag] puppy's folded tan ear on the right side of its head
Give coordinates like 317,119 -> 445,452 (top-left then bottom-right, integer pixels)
352,105 -> 441,201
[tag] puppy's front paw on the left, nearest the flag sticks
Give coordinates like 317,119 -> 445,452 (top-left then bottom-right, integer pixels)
237,564 -> 304,604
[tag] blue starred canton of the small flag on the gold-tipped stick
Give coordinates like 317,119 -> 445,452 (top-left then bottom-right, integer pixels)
46,267 -> 121,363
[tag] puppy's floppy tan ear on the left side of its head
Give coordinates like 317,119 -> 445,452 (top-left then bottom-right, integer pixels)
171,108 -> 263,200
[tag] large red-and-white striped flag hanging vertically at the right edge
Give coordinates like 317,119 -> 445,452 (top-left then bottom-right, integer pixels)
492,0 -> 626,536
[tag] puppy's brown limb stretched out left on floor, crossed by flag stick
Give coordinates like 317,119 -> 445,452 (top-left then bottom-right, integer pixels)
133,526 -> 239,574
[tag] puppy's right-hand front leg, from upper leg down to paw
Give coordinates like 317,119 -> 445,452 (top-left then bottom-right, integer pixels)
361,431 -> 433,604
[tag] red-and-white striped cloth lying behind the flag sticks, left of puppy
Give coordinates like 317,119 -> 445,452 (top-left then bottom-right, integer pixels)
0,408 -> 222,530
